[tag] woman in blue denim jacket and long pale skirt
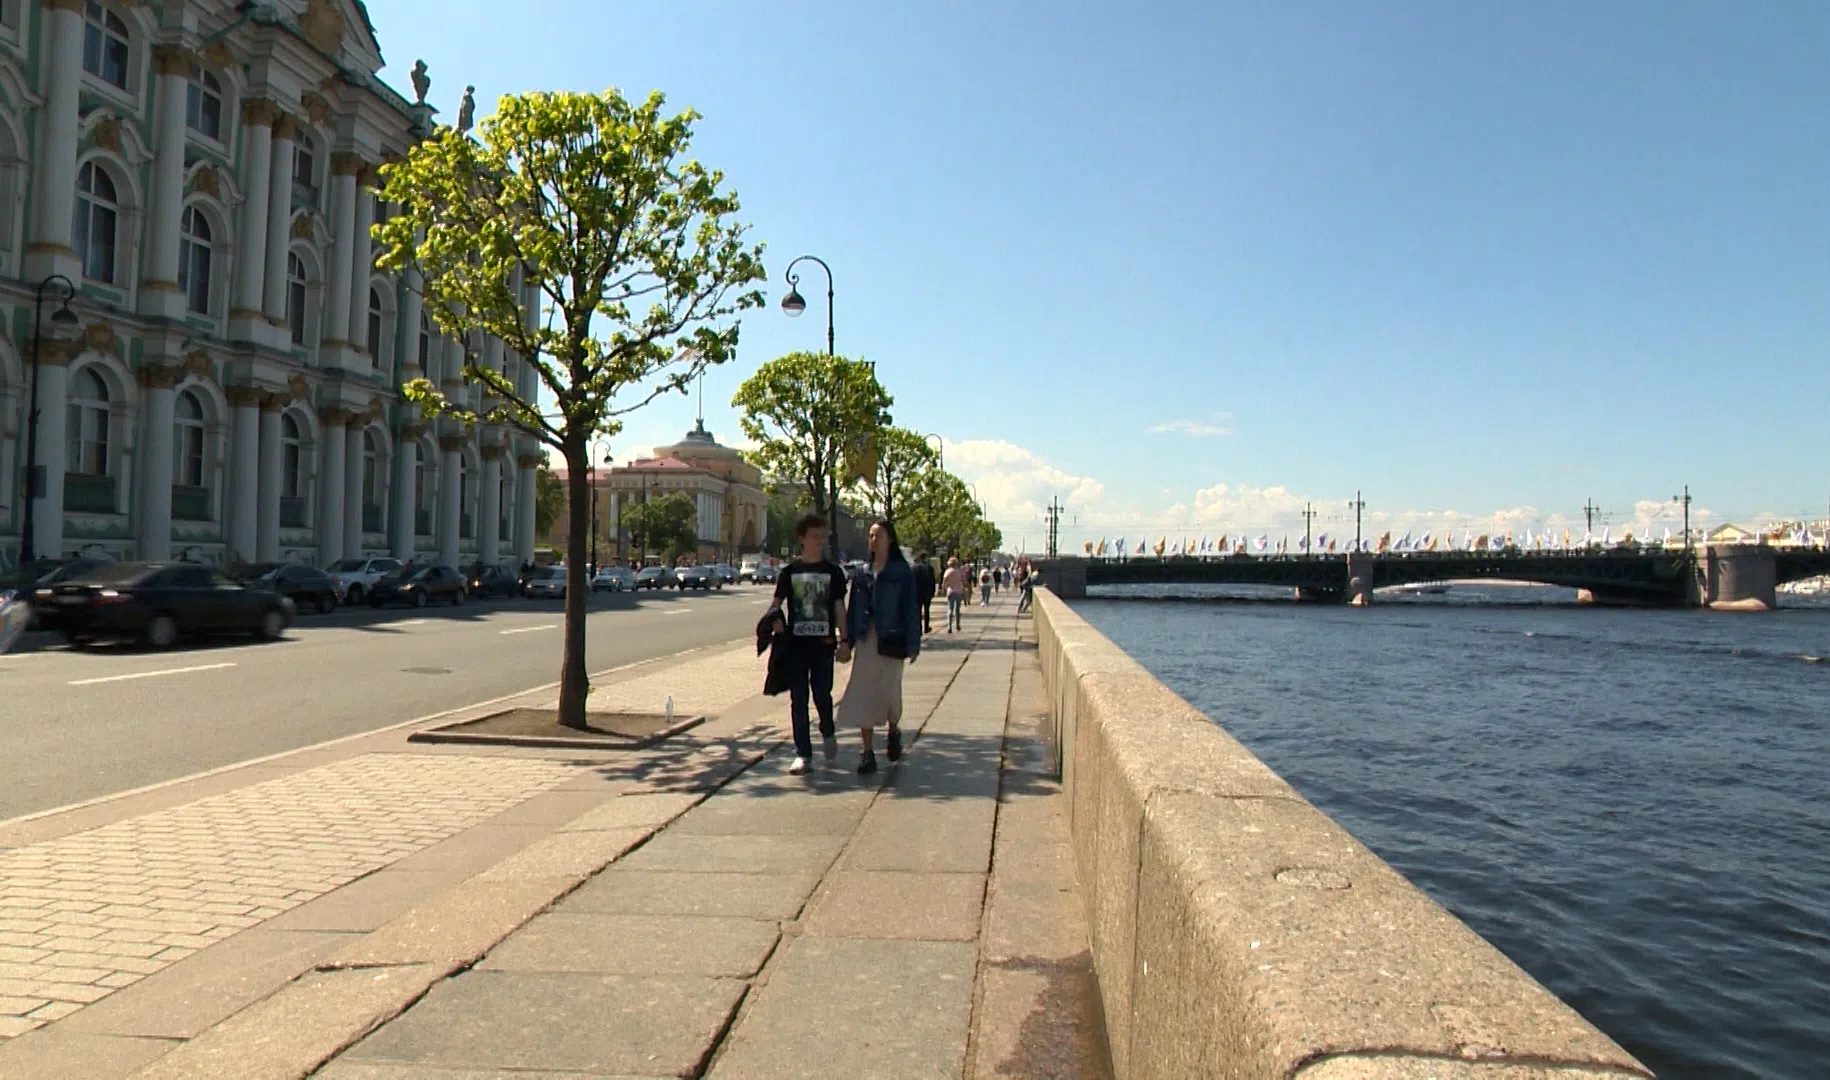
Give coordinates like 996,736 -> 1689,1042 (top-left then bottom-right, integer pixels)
838,520 -> 920,776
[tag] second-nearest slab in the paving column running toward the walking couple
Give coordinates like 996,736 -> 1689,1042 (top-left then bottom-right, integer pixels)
478,912 -> 781,979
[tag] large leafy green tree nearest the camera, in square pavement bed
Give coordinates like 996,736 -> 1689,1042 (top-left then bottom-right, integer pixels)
375,90 -> 763,727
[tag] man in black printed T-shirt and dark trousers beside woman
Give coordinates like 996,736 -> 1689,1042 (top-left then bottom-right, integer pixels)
769,514 -> 845,776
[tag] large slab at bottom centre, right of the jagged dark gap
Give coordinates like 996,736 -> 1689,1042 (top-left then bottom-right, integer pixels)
710,937 -> 977,1080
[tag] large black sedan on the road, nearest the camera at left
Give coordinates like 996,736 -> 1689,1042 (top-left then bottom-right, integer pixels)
33,562 -> 295,648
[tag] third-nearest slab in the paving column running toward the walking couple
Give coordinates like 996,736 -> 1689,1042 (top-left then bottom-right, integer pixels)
556,864 -> 820,919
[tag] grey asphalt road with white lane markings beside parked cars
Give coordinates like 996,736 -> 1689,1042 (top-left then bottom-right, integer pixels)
0,586 -> 770,820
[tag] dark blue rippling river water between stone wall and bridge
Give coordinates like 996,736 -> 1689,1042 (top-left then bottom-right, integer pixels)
1074,586 -> 1830,1080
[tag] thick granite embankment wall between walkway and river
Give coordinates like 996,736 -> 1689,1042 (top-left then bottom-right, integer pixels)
1036,589 -> 1651,1080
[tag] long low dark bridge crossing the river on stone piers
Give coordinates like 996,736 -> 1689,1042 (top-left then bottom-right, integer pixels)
1041,544 -> 1830,610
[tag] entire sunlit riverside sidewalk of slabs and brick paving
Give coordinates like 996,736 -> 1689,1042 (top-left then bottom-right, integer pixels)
0,602 -> 1103,1080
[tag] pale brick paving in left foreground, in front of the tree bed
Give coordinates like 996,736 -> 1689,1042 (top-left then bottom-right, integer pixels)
0,754 -> 576,1040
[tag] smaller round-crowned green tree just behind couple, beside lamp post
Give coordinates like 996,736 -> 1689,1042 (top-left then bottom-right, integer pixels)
730,353 -> 895,560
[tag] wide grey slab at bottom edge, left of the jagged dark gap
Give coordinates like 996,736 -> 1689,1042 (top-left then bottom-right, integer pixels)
342,970 -> 742,1076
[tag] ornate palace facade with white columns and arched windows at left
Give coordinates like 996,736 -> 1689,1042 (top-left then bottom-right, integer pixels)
0,0 -> 540,566
